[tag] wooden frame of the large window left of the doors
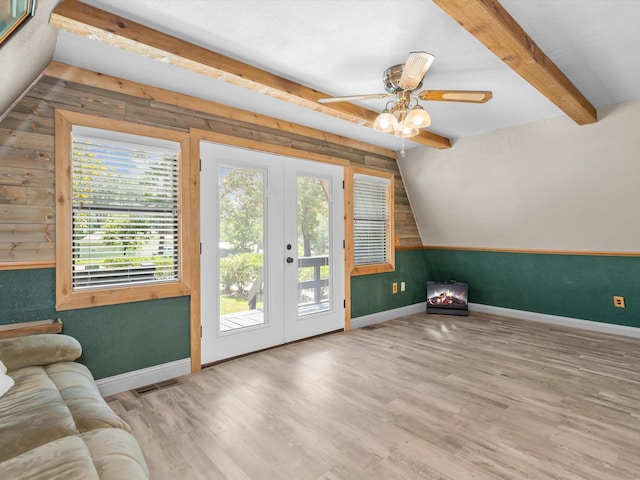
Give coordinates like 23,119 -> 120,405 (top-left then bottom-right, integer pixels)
55,110 -> 191,310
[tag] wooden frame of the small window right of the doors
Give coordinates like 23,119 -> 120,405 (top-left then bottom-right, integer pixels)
345,166 -> 396,277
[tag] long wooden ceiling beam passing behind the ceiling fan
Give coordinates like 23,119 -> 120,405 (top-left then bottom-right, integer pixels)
49,0 -> 451,148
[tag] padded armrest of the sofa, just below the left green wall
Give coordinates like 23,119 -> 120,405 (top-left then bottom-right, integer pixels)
0,334 -> 82,372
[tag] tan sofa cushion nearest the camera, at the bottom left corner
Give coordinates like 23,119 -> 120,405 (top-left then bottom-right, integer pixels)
0,429 -> 149,480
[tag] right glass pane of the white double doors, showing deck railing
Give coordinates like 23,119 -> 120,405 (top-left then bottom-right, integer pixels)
297,175 -> 331,316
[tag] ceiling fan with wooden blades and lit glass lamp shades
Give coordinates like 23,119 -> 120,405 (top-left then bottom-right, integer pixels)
318,52 -> 492,138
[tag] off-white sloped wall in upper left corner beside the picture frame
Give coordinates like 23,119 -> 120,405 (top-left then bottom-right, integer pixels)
0,0 -> 58,118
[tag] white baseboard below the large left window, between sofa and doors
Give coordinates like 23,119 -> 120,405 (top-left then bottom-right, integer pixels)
96,358 -> 191,397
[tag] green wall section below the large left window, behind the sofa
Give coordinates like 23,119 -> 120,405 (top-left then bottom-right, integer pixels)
0,269 -> 190,379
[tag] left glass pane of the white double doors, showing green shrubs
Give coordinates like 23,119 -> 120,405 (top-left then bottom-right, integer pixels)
218,166 -> 265,332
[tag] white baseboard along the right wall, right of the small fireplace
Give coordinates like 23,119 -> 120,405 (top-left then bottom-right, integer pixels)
469,303 -> 640,338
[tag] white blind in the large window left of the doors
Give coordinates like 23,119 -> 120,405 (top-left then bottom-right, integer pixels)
71,127 -> 180,291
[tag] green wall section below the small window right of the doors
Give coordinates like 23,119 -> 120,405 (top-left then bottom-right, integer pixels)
351,249 -> 428,318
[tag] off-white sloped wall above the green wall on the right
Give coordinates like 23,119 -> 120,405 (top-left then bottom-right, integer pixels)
398,101 -> 640,252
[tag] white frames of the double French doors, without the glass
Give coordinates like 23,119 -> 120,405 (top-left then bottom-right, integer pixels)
200,141 -> 345,364
